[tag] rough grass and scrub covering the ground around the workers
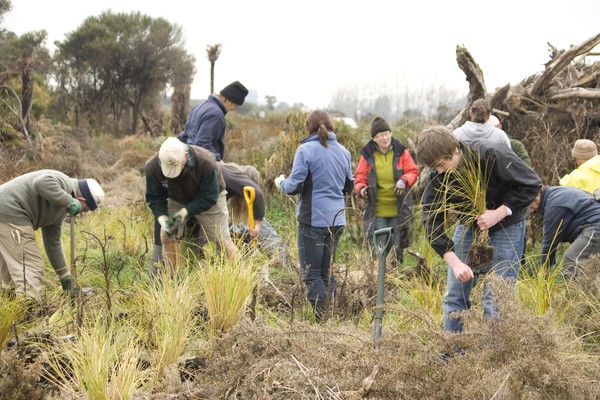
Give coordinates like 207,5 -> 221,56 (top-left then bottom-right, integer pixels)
0,112 -> 600,399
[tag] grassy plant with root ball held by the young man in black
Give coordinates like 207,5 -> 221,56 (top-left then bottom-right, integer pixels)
440,148 -> 493,266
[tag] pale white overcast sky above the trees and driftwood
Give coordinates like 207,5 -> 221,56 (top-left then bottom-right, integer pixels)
4,0 -> 600,108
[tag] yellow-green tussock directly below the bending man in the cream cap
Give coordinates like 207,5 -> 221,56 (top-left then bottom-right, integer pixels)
127,271 -> 200,379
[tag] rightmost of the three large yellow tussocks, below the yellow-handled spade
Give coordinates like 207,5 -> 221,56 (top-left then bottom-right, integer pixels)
200,249 -> 260,335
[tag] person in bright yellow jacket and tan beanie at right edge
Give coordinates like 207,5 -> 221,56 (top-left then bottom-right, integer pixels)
559,139 -> 600,197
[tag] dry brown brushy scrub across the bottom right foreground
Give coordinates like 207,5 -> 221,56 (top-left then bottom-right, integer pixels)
177,280 -> 600,399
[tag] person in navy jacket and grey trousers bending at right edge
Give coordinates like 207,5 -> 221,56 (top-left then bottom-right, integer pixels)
531,186 -> 600,277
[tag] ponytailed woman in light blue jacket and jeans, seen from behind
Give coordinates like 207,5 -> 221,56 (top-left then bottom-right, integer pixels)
275,110 -> 354,322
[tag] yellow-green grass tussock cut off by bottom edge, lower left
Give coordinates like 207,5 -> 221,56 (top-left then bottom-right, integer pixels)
43,316 -> 146,400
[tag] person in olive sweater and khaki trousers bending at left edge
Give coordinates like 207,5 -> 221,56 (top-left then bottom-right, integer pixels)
0,170 -> 104,302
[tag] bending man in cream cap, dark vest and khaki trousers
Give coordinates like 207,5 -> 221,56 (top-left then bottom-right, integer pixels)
145,137 -> 239,273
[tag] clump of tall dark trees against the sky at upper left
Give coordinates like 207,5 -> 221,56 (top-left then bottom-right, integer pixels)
0,0 -> 195,147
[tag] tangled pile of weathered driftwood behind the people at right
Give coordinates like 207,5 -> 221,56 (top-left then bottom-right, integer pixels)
449,34 -> 600,185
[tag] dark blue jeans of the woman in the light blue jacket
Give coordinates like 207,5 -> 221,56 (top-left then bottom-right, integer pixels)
298,224 -> 344,319
